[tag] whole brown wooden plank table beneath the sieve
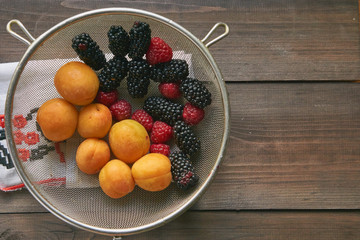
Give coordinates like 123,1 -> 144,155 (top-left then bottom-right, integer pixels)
0,0 -> 360,240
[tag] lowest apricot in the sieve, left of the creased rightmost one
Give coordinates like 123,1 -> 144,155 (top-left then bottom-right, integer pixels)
99,159 -> 135,198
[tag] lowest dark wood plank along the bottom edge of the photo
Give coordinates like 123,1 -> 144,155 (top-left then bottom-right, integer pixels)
0,211 -> 360,240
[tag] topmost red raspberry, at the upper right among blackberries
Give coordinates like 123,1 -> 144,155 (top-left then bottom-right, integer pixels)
146,37 -> 172,65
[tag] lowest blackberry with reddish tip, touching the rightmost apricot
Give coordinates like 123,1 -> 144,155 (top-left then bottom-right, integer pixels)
169,151 -> 199,190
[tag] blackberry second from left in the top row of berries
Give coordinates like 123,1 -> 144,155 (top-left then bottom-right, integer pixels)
108,25 -> 130,57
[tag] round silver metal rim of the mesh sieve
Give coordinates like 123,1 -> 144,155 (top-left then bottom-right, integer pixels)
5,8 -> 230,236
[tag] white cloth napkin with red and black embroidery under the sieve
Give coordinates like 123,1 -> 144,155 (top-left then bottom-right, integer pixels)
0,51 -> 194,191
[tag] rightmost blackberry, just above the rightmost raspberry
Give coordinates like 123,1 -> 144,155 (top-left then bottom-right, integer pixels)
180,78 -> 211,108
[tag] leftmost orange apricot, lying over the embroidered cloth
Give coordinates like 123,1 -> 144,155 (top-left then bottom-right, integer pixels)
36,98 -> 78,142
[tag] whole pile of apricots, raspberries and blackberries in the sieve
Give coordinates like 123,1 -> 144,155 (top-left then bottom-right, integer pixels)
37,21 -> 211,198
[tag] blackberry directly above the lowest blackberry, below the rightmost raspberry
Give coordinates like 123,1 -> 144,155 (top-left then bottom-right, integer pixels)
173,121 -> 200,155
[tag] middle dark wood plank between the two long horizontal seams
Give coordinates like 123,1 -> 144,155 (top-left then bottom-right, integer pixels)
0,83 -> 360,213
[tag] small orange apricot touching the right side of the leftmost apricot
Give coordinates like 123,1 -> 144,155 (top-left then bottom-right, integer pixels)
77,103 -> 112,138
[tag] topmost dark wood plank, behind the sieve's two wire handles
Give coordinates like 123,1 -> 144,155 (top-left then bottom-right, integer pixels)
0,0 -> 360,81
